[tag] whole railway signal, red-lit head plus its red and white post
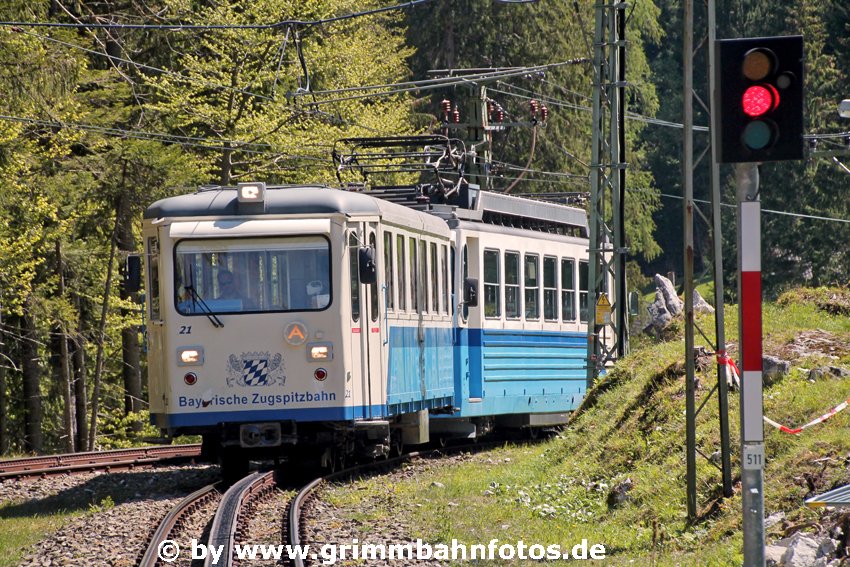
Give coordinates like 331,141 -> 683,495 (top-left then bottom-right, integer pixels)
712,36 -> 803,567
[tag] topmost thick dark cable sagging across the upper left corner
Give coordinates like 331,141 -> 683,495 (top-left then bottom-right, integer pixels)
0,0 -> 432,31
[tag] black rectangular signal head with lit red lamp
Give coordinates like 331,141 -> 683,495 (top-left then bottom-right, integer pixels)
714,36 -> 804,163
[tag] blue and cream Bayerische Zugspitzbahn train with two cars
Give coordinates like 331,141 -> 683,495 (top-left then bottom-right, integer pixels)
143,182 -> 600,478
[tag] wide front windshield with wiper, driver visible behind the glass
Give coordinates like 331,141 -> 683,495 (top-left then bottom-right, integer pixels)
174,236 -> 331,315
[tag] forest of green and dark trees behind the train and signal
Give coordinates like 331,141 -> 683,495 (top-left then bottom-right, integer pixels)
0,0 -> 850,454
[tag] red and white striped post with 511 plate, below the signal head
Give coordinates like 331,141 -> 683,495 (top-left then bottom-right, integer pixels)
735,163 -> 765,566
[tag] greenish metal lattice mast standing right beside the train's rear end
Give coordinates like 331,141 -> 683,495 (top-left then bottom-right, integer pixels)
581,2 -> 628,388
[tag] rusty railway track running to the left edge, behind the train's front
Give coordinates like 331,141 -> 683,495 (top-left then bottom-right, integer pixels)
0,445 -> 201,479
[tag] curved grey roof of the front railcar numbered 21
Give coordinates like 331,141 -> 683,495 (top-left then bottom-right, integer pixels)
144,185 -> 448,233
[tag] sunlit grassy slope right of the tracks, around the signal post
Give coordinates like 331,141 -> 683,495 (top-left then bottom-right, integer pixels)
328,296 -> 850,566
